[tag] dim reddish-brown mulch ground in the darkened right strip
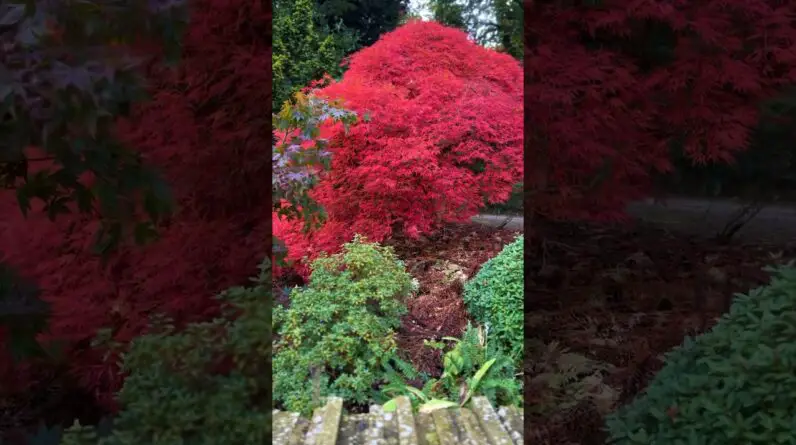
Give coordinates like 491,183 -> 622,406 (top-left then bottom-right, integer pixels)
525,219 -> 796,444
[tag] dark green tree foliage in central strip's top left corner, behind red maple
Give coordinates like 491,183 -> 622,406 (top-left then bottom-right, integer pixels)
271,0 -> 358,110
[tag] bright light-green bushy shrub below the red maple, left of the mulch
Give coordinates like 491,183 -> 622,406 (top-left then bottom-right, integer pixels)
273,237 -> 412,414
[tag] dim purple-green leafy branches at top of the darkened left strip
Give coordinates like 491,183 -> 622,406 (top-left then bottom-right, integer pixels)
0,0 -> 187,253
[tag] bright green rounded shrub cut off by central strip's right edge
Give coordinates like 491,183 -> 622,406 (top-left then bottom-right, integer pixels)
464,235 -> 524,363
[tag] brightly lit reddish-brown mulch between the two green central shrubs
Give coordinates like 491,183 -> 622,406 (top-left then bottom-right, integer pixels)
390,224 -> 519,376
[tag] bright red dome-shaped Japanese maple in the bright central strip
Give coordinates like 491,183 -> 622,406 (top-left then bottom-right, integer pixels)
274,22 -> 523,268
